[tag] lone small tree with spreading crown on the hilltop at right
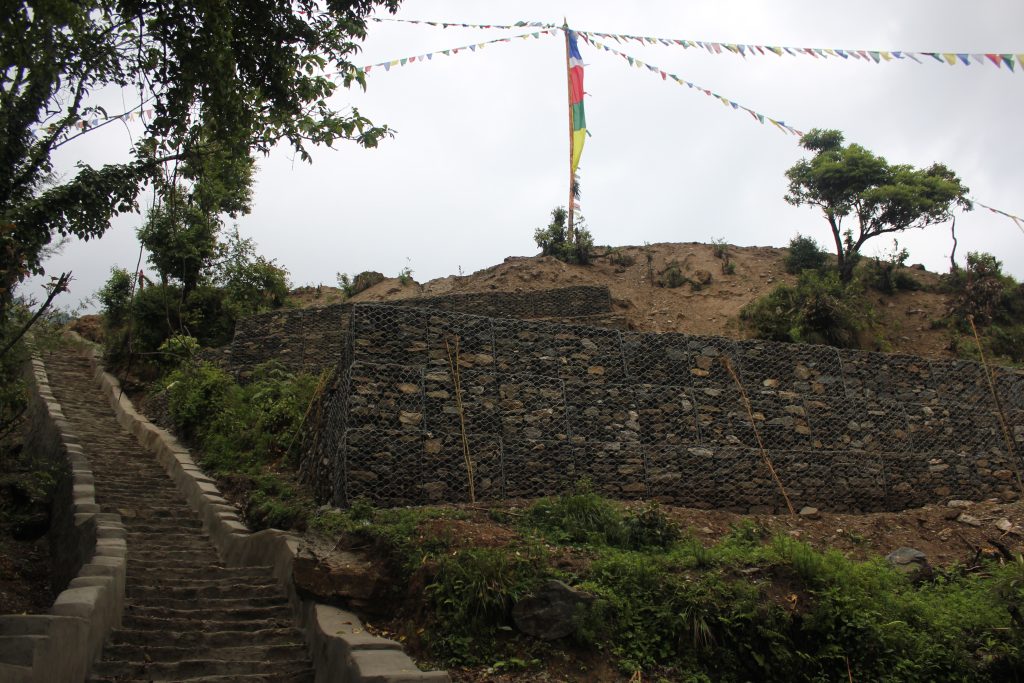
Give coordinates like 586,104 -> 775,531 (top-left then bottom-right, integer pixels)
785,128 -> 972,283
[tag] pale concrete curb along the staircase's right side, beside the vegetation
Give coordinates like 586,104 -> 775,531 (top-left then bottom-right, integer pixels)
79,349 -> 451,683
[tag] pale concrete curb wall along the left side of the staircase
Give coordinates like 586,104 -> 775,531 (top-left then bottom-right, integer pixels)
0,352 -> 127,683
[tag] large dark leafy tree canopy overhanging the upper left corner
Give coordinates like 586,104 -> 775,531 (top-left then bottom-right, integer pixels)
0,0 -> 399,319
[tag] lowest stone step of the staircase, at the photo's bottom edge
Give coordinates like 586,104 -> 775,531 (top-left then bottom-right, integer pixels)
94,658 -> 309,681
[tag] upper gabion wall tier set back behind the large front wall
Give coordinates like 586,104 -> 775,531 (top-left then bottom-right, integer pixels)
228,286 -> 626,382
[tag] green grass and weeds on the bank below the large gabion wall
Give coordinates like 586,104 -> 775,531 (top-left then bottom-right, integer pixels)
312,490 -> 1024,681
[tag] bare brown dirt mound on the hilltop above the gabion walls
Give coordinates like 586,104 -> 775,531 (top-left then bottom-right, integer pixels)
296,243 -> 950,357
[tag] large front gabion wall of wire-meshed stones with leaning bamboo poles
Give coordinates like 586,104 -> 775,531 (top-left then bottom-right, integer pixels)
303,305 -> 1024,512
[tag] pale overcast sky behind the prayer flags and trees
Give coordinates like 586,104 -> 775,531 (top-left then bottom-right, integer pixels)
29,0 -> 1024,307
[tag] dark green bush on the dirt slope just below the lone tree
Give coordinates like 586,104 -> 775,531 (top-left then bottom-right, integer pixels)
739,270 -> 872,348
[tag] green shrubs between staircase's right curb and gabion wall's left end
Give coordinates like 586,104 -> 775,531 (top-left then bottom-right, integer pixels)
164,362 -> 316,529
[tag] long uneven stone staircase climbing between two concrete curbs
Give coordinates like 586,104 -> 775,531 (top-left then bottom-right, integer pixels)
45,352 -> 314,682
